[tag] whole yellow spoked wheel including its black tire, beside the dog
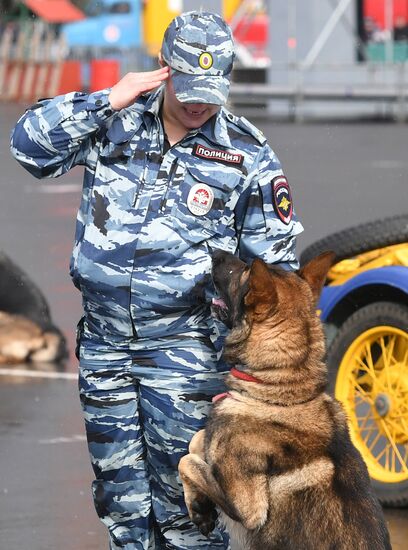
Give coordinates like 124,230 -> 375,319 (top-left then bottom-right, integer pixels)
328,302 -> 408,504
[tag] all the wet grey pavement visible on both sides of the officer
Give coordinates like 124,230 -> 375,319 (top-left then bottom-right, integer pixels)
0,103 -> 408,550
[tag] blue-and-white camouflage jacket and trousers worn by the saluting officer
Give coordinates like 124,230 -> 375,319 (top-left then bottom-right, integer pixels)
11,9 -> 302,550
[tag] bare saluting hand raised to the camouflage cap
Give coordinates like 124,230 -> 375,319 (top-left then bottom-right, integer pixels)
109,67 -> 170,111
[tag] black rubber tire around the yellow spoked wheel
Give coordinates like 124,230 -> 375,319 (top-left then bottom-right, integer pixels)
326,302 -> 408,508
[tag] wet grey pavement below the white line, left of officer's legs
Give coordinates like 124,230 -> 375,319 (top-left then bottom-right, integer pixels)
0,377 -> 107,550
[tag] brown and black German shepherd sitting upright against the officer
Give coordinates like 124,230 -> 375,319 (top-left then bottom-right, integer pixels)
179,251 -> 391,550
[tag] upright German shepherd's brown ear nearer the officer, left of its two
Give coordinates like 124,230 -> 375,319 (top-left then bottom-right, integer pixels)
245,258 -> 277,321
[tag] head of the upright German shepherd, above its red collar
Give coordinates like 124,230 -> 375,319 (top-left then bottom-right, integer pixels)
212,251 -> 334,378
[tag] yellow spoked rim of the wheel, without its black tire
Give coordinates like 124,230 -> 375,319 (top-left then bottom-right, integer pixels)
335,326 -> 408,483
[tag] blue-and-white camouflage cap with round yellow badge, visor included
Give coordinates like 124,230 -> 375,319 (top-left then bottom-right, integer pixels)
161,11 -> 235,105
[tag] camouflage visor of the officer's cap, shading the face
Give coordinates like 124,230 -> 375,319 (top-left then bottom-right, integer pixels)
171,69 -> 230,105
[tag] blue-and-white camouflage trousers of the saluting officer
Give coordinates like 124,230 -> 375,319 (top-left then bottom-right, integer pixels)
79,335 -> 229,550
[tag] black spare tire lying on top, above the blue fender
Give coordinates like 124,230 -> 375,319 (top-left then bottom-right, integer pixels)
300,214 -> 408,265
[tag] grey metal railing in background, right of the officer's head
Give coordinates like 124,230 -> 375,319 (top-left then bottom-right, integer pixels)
230,62 -> 408,121
